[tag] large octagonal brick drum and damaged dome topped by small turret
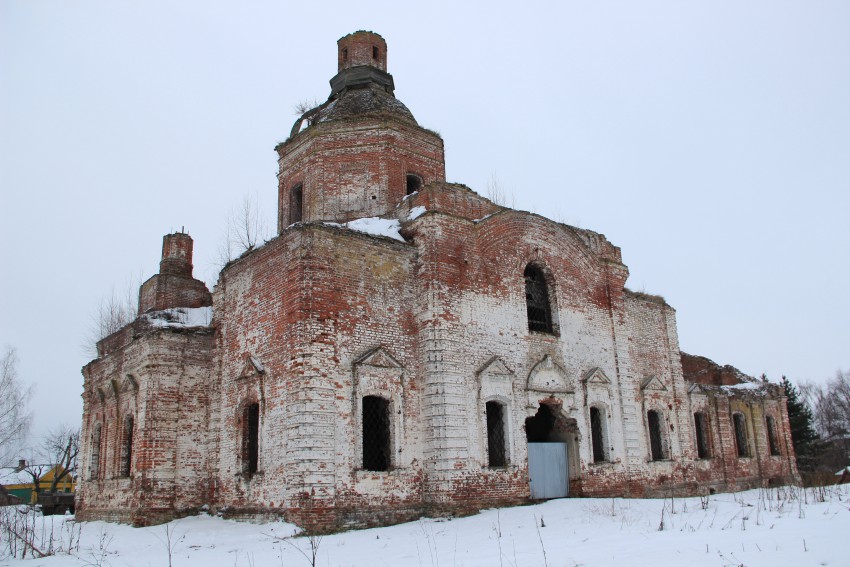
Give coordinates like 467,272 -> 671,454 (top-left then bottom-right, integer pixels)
276,31 -> 446,232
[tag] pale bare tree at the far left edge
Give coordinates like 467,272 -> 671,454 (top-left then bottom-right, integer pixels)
0,347 -> 32,466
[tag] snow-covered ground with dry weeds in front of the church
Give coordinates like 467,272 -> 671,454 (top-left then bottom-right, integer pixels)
0,486 -> 850,567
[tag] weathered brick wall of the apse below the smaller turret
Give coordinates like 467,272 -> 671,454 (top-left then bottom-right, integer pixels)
77,329 -> 215,524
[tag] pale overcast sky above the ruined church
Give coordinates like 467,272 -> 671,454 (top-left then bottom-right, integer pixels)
0,0 -> 850,440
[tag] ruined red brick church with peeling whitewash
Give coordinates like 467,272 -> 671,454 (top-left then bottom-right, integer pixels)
77,31 -> 797,531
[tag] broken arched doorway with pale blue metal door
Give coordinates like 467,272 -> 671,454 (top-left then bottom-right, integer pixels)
525,403 -> 578,500
